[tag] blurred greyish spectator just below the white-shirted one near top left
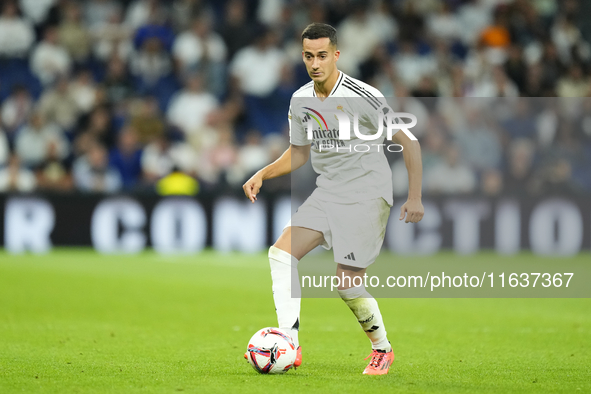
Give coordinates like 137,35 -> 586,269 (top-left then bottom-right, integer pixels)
39,77 -> 80,131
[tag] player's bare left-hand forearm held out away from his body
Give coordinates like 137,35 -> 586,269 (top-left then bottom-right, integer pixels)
242,144 -> 310,202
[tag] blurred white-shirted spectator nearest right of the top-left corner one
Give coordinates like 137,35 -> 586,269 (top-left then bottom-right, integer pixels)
31,26 -> 72,85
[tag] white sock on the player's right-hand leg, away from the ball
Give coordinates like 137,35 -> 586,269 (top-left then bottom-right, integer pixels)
339,286 -> 392,351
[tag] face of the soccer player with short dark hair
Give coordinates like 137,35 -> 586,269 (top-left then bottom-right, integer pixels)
302,37 -> 340,83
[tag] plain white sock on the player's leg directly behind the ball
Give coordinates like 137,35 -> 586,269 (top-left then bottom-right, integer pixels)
269,246 -> 301,348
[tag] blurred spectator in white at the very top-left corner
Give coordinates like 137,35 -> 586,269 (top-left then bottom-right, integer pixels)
0,1 -> 35,57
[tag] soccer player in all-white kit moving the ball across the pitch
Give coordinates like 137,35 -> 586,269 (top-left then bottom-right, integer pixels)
243,23 -> 424,375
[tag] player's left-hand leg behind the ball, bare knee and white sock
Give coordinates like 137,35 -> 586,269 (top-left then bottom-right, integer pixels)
269,226 -> 324,347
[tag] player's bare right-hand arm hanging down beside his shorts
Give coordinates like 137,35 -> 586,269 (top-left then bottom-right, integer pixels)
392,130 -> 425,223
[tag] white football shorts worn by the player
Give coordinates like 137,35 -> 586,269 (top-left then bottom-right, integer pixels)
285,195 -> 390,268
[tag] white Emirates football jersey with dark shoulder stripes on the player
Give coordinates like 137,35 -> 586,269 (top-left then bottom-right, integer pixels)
288,71 -> 401,206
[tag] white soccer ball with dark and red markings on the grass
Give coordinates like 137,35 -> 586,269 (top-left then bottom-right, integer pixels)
246,327 -> 297,374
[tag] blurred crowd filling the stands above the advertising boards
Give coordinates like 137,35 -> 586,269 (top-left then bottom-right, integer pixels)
0,0 -> 591,195
